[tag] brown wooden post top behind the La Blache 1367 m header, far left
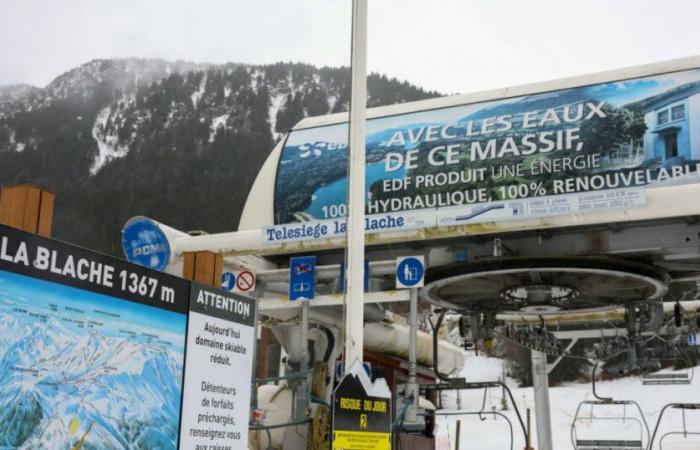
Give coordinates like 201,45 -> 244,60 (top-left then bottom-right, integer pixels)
0,184 -> 55,237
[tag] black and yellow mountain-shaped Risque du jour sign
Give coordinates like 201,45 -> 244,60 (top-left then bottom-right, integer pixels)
332,361 -> 391,450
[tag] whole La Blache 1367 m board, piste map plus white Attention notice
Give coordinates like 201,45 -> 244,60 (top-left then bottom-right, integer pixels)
0,226 -> 255,450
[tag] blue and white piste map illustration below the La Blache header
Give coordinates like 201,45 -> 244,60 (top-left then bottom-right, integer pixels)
0,270 -> 186,450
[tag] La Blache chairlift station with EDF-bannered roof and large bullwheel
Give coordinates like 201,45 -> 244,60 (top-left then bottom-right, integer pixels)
127,57 -> 700,450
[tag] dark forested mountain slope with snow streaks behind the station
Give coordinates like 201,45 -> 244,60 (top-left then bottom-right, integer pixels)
0,59 -> 438,255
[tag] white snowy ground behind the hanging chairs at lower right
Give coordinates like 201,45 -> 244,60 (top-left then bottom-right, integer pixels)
437,355 -> 700,450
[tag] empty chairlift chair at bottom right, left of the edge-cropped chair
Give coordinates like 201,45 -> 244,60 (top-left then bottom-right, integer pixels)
571,362 -> 651,450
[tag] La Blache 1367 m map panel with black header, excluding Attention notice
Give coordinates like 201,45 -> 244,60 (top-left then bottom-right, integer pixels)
0,226 -> 189,450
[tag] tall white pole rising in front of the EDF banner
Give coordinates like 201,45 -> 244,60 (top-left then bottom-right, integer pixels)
345,0 -> 367,369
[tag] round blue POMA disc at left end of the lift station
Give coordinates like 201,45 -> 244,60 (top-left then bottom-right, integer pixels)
122,217 -> 170,271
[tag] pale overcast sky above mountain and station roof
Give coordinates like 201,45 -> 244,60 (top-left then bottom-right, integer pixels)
0,0 -> 700,94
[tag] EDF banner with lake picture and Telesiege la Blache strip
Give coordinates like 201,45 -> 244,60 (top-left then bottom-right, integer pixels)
264,69 -> 700,242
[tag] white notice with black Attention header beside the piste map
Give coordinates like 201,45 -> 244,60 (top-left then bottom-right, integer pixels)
180,284 -> 255,450
